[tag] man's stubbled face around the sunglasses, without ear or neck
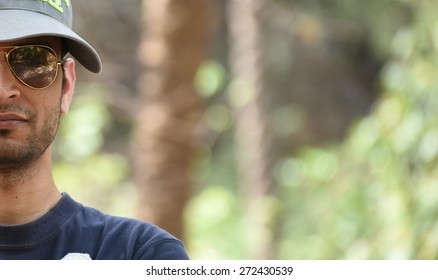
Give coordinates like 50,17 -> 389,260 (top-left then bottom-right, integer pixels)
0,37 -> 68,169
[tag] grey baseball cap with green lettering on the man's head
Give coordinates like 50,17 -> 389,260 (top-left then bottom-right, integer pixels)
0,0 -> 102,73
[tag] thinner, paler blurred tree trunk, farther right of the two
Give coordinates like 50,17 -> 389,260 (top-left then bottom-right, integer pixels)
228,0 -> 277,259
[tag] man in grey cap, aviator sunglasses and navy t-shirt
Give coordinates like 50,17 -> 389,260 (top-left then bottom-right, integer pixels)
0,0 -> 188,260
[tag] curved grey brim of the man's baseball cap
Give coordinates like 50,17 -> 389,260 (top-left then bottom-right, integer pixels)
0,10 -> 102,73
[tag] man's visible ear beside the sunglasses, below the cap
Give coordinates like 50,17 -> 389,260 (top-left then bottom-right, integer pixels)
61,58 -> 76,115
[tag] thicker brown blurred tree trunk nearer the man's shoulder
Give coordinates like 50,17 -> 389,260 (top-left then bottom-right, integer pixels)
134,0 -> 212,239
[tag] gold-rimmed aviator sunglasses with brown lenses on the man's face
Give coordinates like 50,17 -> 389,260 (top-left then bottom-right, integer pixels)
0,45 -> 63,89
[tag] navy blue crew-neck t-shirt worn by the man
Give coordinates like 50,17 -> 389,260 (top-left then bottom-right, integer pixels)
0,193 -> 188,260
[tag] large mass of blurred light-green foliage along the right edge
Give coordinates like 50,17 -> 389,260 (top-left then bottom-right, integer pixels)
278,1 -> 438,259
